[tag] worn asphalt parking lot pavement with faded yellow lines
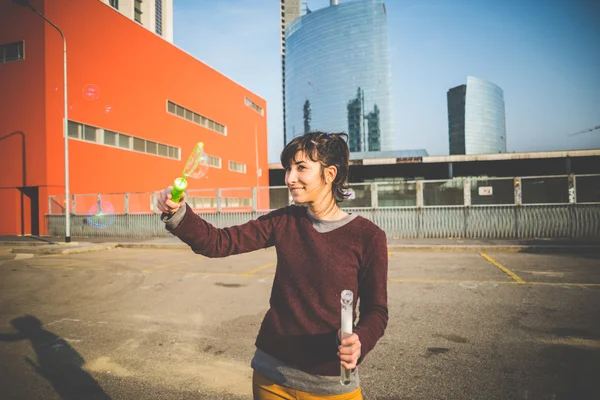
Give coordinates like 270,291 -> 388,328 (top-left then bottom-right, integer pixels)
0,245 -> 600,400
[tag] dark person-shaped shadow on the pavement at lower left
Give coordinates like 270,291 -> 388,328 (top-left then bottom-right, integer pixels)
0,315 -> 110,400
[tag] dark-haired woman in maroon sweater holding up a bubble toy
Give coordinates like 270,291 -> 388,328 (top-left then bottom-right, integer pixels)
158,132 -> 388,400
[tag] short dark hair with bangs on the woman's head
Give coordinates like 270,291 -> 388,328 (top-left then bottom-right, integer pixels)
281,131 -> 350,201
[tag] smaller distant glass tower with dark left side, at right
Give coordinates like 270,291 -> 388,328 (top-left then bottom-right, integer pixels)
448,76 -> 506,154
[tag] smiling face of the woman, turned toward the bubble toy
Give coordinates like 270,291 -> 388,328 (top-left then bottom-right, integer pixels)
285,151 -> 335,204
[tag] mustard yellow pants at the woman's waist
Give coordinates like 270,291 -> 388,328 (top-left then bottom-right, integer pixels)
252,371 -> 362,400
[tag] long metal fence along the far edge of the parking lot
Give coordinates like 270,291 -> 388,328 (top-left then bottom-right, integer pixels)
46,175 -> 600,239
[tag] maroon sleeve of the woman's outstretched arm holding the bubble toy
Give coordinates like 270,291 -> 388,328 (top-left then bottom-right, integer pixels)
166,206 -> 285,258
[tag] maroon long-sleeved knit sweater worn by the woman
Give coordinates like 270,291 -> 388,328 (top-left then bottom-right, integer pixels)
171,206 -> 388,376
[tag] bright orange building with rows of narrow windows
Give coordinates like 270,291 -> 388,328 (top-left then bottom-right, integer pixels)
0,0 -> 268,235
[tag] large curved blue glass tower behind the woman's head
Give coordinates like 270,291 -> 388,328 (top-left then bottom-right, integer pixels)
284,0 -> 398,152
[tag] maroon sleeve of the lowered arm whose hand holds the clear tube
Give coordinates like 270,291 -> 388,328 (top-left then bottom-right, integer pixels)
354,230 -> 388,363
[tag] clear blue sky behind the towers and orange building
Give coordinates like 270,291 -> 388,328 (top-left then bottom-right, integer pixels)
174,0 -> 600,162
